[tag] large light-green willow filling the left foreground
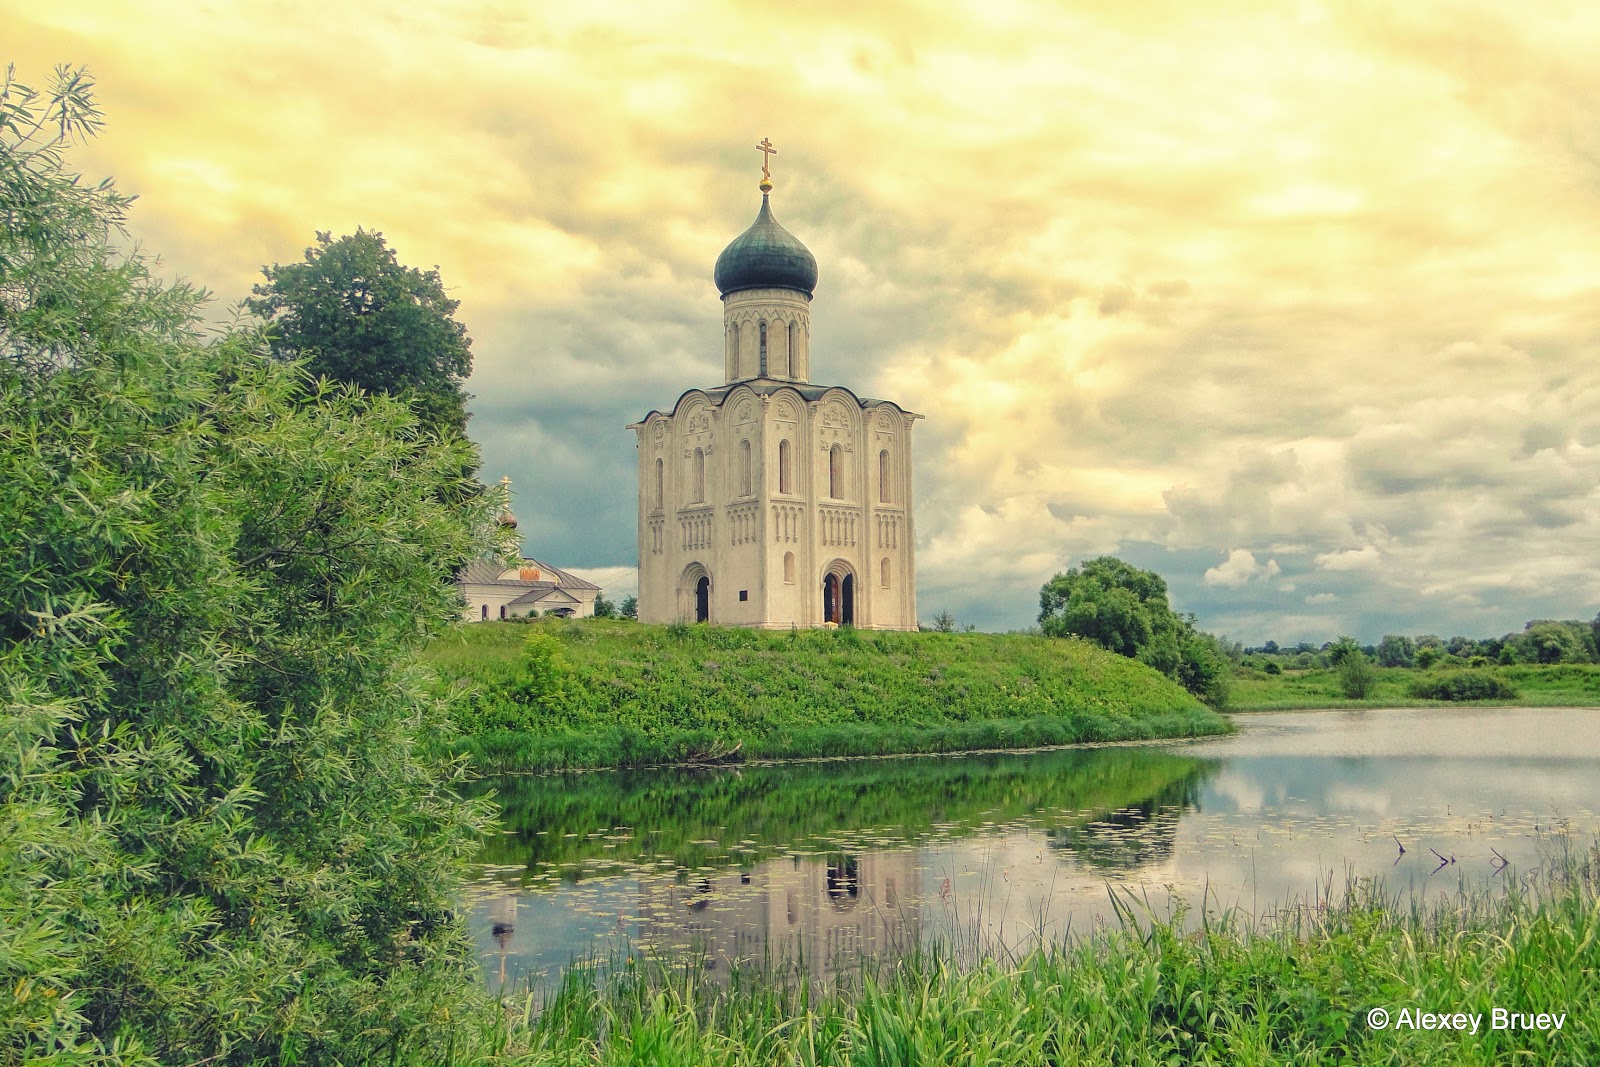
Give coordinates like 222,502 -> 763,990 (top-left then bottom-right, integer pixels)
0,70 -> 509,1065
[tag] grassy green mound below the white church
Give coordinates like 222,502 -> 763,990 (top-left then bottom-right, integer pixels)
422,619 -> 1230,771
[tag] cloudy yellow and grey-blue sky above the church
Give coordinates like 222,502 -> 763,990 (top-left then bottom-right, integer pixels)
18,0 -> 1600,643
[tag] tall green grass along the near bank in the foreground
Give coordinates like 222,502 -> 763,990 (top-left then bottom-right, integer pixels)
507,846 -> 1600,1065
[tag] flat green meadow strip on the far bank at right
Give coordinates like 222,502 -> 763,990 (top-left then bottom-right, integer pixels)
1227,664 -> 1600,712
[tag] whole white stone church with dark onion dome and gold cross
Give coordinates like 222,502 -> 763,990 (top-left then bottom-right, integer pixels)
629,154 -> 922,630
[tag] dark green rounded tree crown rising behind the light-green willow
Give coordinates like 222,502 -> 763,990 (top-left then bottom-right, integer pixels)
245,229 -> 472,437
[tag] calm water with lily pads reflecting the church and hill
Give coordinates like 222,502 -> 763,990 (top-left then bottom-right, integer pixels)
472,709 -> 1600,987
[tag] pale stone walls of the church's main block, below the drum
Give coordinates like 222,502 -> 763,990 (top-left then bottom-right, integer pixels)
637,395 -> 917,629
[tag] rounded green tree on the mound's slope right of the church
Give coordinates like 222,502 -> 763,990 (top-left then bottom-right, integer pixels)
1038,555 -> 1230,707
